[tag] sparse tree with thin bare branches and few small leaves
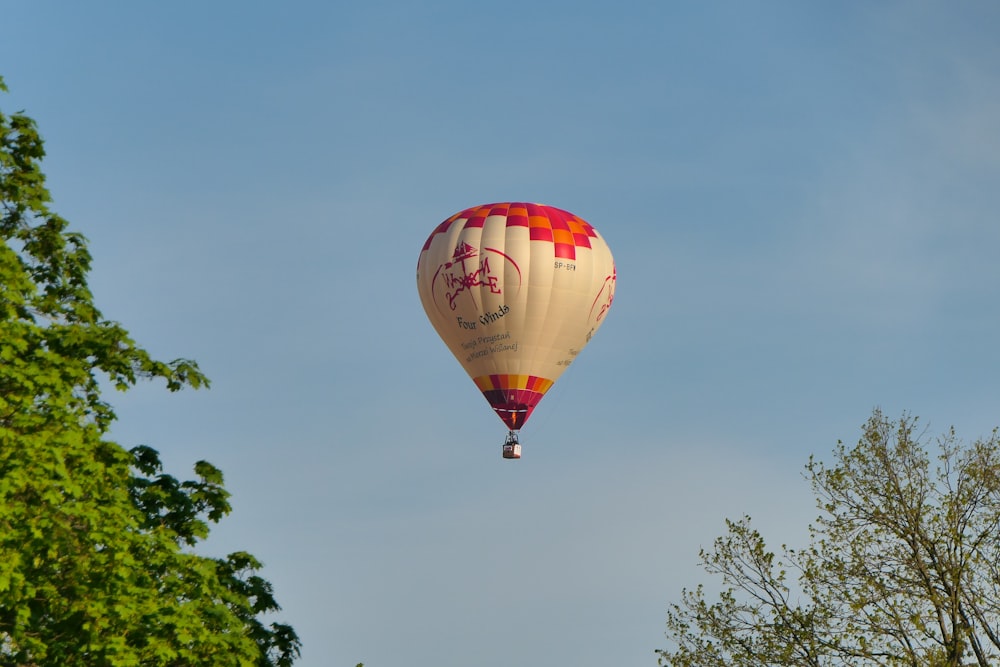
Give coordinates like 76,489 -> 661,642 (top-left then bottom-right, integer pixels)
657,410 -> 1000,667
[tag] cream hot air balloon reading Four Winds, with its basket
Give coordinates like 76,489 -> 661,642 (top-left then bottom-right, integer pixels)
417,202 -> 616,459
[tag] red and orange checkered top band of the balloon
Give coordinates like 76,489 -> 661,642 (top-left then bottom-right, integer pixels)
423,202 -> 597,259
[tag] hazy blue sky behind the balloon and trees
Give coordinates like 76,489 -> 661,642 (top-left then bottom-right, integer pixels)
0,0 -> 1000,667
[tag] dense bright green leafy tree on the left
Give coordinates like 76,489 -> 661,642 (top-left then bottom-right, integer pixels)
0,79 -> 299,667
